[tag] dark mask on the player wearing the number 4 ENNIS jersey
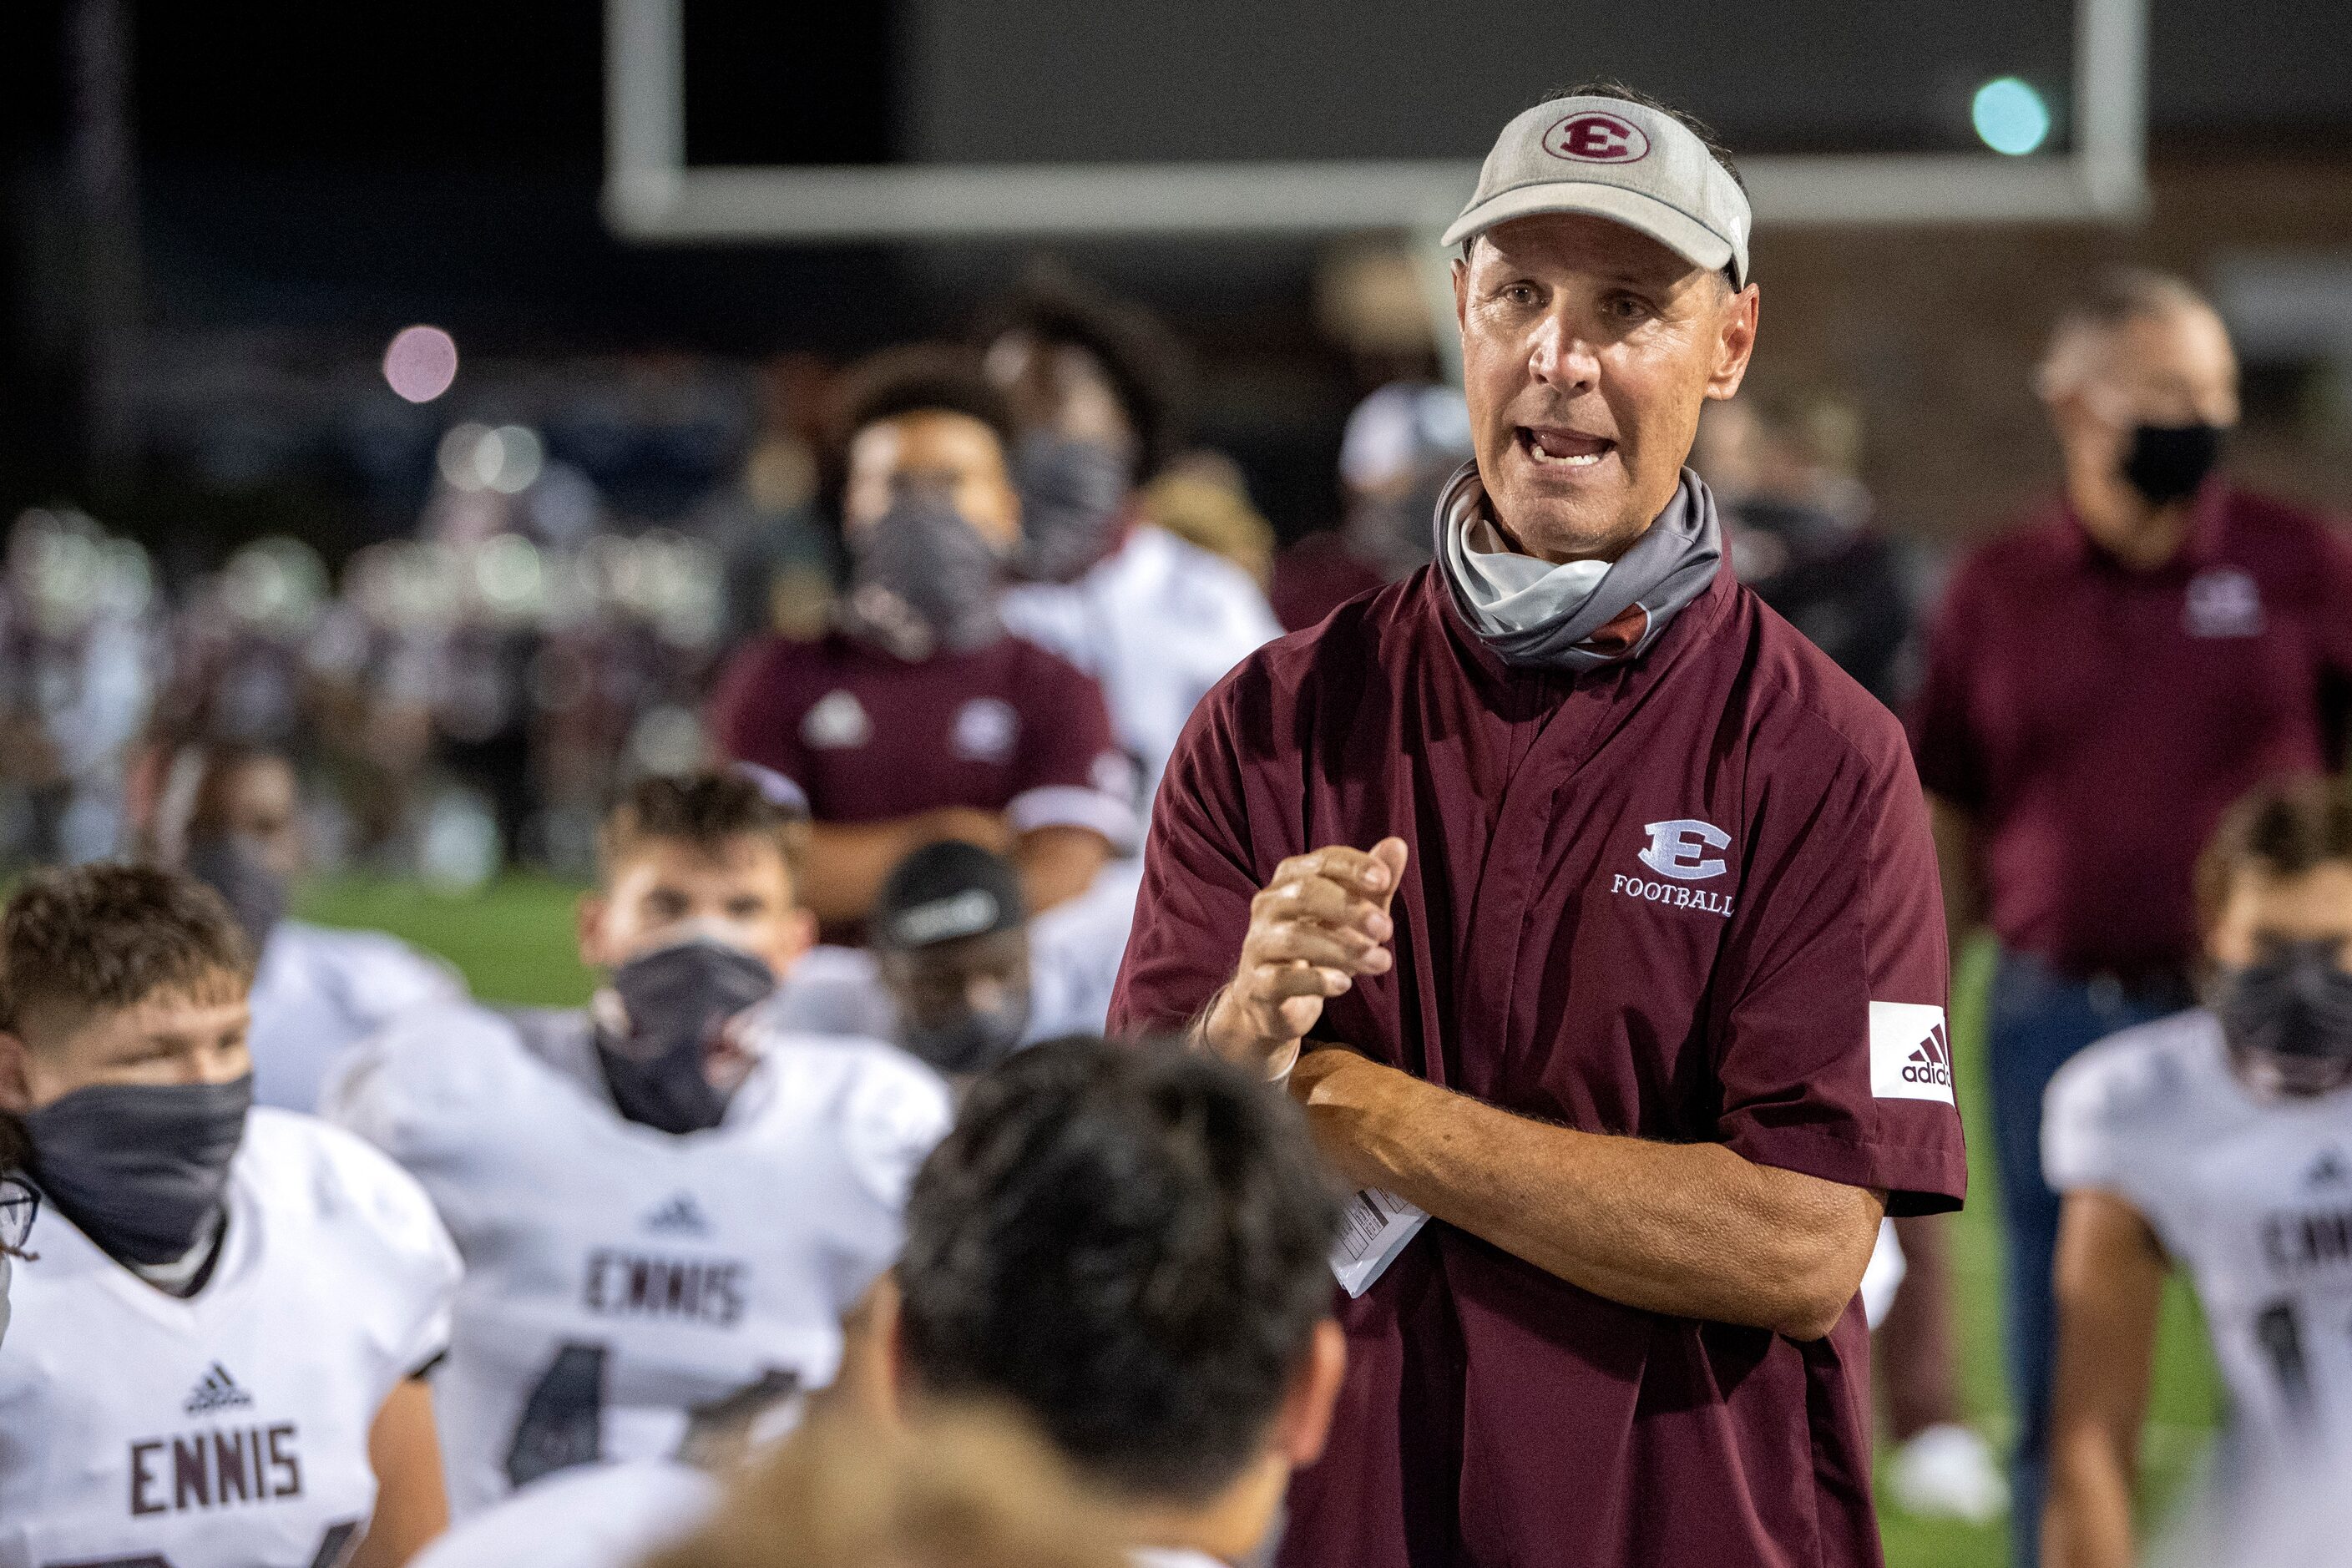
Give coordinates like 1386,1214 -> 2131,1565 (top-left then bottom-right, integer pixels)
593,943 -> 776,1133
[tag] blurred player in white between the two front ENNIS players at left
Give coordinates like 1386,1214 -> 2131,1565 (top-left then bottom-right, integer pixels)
148,747 -> 466,1112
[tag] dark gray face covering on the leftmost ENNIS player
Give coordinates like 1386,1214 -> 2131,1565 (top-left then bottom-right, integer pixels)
23,1075 -> 254,1267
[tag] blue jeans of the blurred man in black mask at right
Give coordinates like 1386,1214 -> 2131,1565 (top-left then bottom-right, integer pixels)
1985,949 -> 2190,1568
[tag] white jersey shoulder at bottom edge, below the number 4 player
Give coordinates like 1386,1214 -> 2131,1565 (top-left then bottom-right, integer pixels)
412,1459 -> 720,1568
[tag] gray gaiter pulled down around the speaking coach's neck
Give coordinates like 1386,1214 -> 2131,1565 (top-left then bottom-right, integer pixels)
1433,463 -> 1724,675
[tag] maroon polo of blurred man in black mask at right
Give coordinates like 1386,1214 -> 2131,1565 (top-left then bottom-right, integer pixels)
1912,482 -> 2352,978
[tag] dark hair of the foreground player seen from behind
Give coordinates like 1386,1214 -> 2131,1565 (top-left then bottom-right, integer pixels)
898,1037 -> 1338,1502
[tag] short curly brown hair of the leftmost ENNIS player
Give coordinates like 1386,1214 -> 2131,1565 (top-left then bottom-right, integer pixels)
0,862 -> 254,1032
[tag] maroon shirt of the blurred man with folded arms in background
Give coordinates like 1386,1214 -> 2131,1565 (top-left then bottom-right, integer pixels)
711,632 -> 1136,847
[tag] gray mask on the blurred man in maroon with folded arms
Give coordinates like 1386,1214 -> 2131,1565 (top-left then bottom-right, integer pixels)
842,489 -> 1004,660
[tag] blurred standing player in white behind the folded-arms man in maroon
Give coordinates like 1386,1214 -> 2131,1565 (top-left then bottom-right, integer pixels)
984,289 -> 1282,807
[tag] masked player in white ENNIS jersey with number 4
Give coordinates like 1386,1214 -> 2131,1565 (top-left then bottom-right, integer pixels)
325,773 -> 948,1516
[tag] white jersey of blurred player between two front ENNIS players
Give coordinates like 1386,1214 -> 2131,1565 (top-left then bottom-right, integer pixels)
247,919 -> 466,1112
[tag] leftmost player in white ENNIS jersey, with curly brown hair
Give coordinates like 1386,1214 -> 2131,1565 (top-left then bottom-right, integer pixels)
0,865 -> 458,1568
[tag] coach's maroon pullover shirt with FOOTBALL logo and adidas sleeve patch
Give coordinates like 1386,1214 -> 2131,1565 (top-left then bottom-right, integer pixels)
1112,569 -> 1966,1568
